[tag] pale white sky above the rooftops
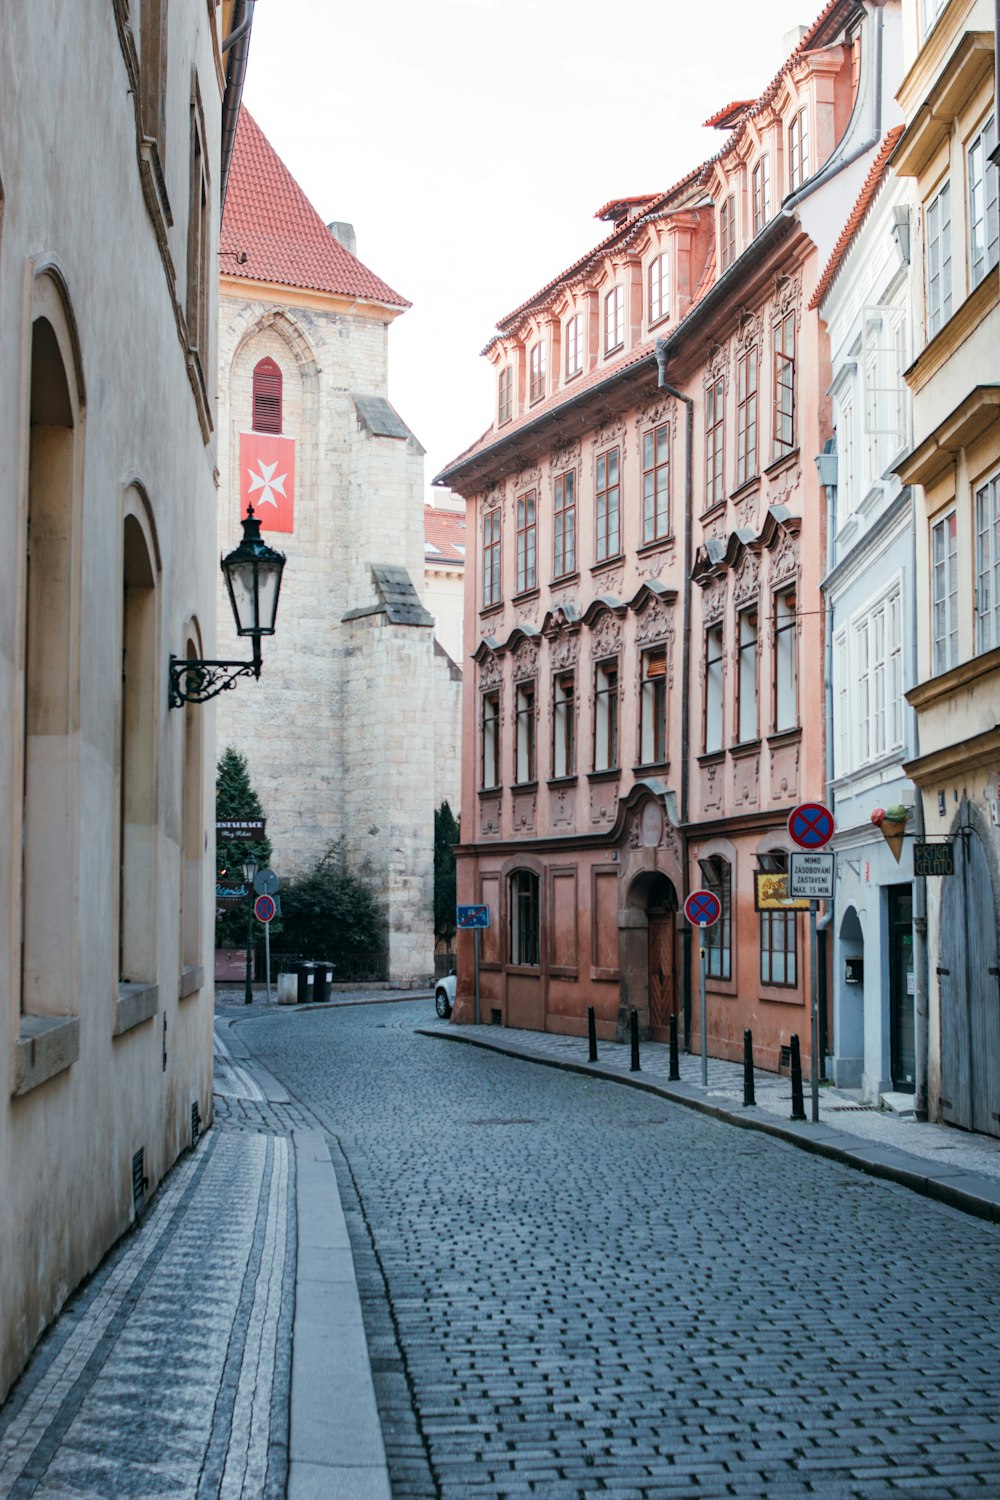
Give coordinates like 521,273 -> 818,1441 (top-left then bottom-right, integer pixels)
243,0 -> 820,500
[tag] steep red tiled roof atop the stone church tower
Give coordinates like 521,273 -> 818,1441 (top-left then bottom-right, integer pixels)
220,105 -> 409,308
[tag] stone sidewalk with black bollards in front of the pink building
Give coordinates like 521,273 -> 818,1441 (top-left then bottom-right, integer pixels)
418,1022 -> 1000,1223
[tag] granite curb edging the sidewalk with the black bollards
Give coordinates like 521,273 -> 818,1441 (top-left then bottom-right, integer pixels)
417,1026 -> 1000,1224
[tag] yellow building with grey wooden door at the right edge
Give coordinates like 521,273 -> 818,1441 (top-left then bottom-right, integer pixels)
892,0 -> 1000,1136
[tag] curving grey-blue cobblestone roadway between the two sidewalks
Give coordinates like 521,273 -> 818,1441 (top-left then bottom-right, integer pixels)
240,1002 -> 1000,1500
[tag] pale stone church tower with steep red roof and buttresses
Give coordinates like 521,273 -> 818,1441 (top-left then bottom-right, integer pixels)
219,111 -> 460,986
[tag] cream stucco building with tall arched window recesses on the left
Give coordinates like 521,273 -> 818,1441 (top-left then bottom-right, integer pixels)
0,0 -> 249,1400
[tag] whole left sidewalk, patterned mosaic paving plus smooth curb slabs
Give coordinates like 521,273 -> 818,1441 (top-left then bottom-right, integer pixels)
0,1016 -> 390,1500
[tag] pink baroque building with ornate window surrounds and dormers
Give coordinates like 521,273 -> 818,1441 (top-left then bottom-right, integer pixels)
439,0 -> 898,1068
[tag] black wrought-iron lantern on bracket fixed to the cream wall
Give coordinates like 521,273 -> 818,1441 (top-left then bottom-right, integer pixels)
169,506 -> 285,708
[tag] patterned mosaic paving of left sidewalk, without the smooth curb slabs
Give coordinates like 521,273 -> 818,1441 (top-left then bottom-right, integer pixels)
0,1032 -> 295,1500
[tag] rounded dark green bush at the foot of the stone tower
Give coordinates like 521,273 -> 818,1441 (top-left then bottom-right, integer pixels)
282,843 -> 385,977
